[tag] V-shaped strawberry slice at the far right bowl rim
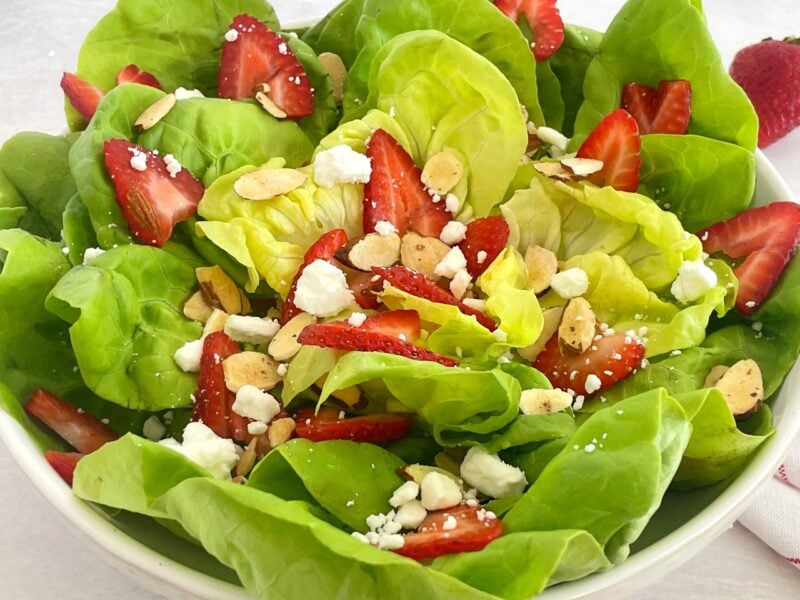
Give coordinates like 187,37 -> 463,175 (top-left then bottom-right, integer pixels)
697,202 -> 800,315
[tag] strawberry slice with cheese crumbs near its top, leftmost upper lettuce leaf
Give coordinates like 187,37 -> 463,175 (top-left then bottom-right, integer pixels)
103,139 -> 204,248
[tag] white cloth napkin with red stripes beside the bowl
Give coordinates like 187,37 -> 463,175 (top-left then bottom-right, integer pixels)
739,440 -> 800,569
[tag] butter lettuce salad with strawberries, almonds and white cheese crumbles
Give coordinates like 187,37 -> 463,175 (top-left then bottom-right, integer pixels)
0,0 -> 800,598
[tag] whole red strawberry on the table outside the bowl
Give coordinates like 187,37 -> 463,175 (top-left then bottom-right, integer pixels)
731,38 -> 800,148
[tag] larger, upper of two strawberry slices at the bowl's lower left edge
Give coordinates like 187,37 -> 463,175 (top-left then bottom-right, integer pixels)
25,388 -> 119,454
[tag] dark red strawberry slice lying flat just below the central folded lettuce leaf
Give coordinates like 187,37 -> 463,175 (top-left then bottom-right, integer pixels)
294,406 -> 414,444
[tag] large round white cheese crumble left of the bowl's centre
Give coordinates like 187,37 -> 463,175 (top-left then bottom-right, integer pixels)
294,259 -> 354,317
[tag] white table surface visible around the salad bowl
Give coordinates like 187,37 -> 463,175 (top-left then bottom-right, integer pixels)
0,0 -> 800,600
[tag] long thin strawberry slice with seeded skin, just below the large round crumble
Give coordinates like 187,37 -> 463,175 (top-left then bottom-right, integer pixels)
297,321 -> 458,367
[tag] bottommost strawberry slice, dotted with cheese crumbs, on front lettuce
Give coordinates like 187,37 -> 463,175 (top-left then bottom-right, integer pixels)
394,504 -> 503,560
